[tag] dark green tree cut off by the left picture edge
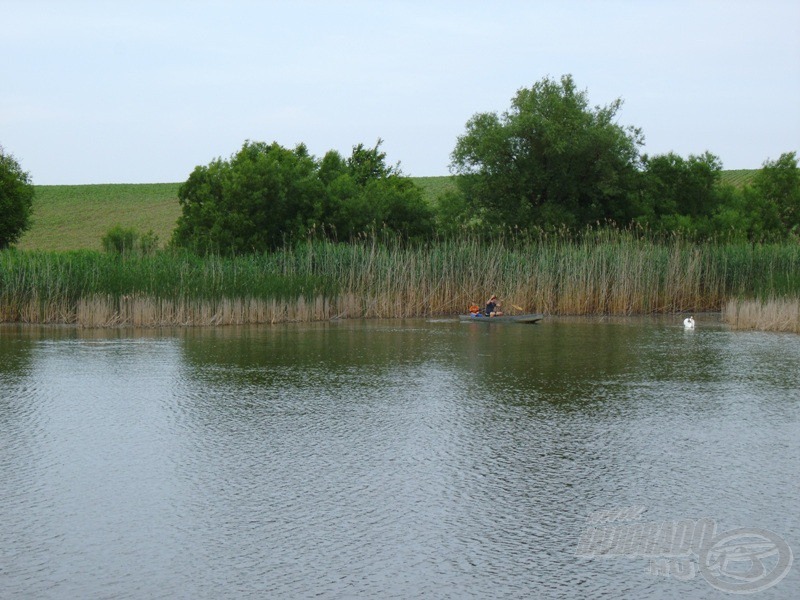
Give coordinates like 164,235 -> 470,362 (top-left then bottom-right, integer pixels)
0,146 -> 34,249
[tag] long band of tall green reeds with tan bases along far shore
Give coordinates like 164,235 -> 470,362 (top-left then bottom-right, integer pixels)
0,230 -> 800,327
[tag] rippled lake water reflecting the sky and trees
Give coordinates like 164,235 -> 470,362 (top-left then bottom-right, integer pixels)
0,316 -> 800,599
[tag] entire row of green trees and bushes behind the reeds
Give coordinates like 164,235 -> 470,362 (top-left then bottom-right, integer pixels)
0,75 -> 800,254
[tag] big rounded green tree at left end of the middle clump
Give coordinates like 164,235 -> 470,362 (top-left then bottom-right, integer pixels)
173,141 -> 325,254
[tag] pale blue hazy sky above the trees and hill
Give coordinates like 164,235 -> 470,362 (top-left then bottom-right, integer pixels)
0,0 -> 800,185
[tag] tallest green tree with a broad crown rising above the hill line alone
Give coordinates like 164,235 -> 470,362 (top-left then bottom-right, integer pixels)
451,75 -> 643,228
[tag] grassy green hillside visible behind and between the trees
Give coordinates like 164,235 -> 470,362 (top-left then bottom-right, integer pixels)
17,170 -> 756,250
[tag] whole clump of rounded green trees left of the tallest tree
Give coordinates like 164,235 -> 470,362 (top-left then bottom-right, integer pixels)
173,140 -> 433,254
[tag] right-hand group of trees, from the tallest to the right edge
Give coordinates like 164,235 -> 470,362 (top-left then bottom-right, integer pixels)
440,75 -> 800,240
